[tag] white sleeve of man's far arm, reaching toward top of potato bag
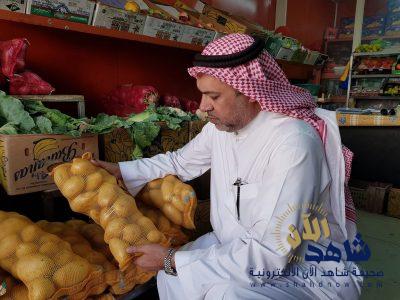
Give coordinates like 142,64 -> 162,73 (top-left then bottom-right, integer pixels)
119,123 -> 213,196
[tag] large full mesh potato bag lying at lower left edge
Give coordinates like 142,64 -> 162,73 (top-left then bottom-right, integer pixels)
0,211 -> 102,300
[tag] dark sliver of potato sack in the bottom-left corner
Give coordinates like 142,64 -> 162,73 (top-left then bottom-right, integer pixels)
0,268 -> 29,300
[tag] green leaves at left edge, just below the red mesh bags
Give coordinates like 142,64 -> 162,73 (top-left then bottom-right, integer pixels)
0,91 -> 36,131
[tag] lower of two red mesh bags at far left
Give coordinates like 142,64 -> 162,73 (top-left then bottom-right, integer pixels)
10,71 -> 54,95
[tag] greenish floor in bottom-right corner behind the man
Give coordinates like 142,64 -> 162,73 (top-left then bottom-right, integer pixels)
357,211 -> 400,300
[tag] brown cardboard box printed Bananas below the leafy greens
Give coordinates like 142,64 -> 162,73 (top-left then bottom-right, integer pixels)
0,134 -> 98,195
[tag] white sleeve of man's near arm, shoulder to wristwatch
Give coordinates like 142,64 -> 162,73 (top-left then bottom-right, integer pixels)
175,135 -> 325,299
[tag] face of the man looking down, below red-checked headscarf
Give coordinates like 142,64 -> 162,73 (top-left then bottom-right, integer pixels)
197,75 -> 260,132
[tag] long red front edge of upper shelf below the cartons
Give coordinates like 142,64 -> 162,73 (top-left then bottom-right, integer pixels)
0,10 -> 204,52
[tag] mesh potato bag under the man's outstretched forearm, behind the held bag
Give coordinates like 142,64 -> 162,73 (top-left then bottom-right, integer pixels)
136,175 -> 197,229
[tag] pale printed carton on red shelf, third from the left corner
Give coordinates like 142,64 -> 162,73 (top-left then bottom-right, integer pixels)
93,3 -> 146,34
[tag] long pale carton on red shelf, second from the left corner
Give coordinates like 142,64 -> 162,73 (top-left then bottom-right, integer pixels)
26,0 -> 95,24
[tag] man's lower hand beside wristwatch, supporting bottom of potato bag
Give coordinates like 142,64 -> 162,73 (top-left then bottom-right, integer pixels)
126,244 -> 175,271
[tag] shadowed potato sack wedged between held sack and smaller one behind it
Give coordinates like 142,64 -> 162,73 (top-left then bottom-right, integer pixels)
138,202 -> 189,247
